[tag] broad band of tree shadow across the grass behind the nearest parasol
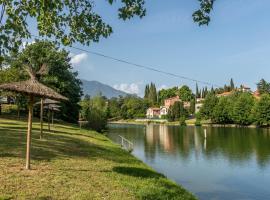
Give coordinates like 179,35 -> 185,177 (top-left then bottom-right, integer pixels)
0,123 -> 139,166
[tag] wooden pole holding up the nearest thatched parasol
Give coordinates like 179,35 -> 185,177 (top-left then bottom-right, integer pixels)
25,95 -> 34,170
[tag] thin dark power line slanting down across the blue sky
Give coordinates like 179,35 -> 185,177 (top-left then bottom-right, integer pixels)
31,35 -> 221,87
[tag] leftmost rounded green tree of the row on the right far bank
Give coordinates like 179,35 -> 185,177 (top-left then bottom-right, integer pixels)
200,93 -> 218,119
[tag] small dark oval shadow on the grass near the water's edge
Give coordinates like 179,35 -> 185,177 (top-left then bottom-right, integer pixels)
113,167 -> 165,178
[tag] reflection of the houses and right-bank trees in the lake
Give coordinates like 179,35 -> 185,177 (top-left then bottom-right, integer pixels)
145,124 -> 270,167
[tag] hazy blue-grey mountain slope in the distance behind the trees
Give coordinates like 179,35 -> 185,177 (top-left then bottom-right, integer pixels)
82,80 -> 129,98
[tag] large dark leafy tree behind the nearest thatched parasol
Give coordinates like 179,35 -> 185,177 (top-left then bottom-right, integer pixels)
9,41 -> 82,122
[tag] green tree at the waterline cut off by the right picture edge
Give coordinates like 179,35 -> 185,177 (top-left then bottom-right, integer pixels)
254,94 -> 270,126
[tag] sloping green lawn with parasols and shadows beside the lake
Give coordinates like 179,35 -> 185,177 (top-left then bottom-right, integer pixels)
0,118 -> 195,200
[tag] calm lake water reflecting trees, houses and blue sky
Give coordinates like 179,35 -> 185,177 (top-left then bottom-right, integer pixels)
109,124 -> 270,200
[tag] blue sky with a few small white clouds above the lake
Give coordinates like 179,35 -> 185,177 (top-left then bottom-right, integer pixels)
65,0 -> 270,95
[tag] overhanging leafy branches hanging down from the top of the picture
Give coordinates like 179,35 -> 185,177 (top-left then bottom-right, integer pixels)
0,0 -> 214,56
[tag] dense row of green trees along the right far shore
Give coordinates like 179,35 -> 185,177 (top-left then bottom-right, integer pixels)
198,79 -> 270,126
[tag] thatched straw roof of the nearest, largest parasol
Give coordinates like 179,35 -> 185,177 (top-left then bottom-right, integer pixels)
0,77 -> 68,100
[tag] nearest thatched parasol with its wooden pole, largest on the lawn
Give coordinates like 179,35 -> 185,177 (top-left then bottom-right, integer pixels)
0,67 -> 68,169
